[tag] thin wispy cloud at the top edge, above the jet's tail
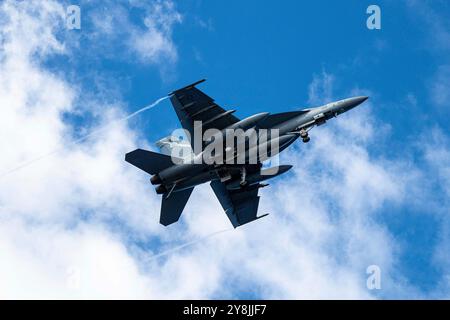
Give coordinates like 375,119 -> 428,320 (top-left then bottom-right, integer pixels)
82,0 -> 182,79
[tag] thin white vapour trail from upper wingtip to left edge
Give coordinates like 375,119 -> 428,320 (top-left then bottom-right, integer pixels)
0,96 -> 168,178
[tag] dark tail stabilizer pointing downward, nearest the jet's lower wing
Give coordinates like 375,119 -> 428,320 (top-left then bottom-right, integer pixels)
159,188 -> 194,226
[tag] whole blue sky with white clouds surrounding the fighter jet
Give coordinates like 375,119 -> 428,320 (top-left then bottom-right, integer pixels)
0,0 -> 450,299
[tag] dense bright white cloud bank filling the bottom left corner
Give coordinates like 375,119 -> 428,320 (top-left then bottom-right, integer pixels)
0,221 -> 152,299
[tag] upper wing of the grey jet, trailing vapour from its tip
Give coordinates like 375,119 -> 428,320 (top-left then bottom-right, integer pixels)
169,80 -> 239,153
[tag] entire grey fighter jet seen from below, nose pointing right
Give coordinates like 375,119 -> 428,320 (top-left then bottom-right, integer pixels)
125,79 -> 368,228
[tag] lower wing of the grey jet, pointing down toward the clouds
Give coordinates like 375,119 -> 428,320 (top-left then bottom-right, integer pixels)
211,180 -> 267,228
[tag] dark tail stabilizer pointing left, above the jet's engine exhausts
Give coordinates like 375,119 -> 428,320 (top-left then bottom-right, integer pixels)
125,149 -> 182,174
